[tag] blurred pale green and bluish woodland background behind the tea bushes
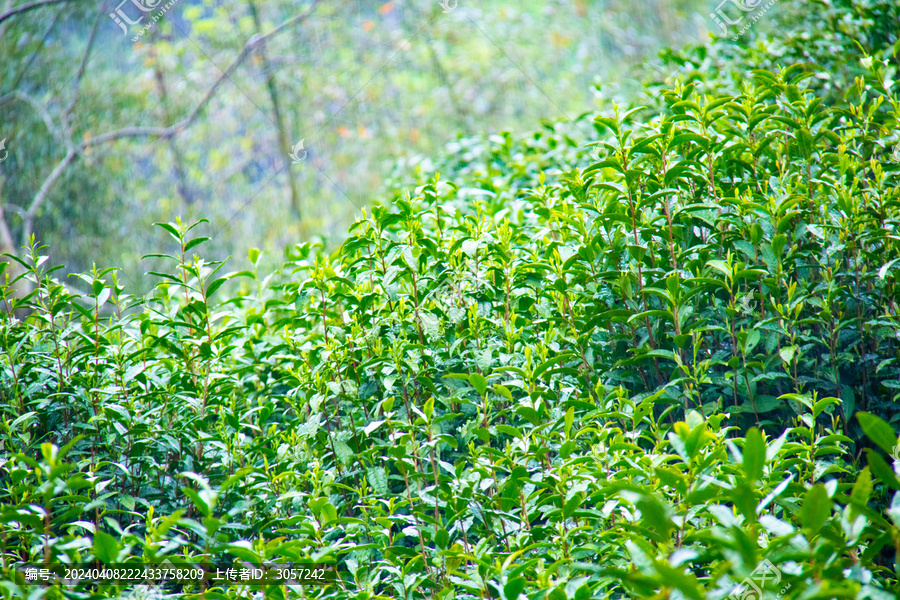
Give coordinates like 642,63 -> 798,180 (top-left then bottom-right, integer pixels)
0,0 -> 716,289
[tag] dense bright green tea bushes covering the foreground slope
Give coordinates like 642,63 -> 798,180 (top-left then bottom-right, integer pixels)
0,1 -> 900,600
